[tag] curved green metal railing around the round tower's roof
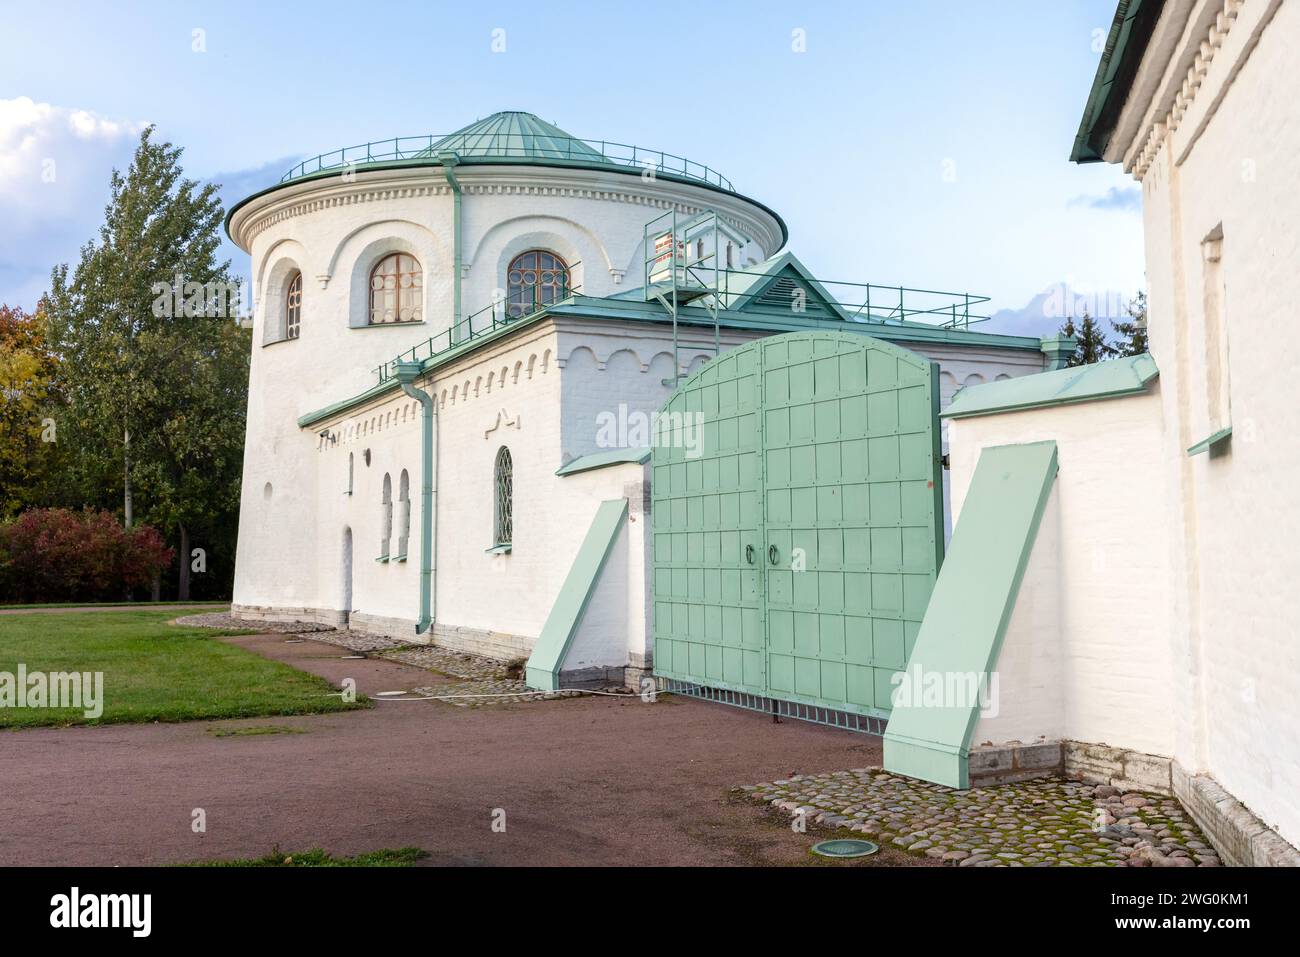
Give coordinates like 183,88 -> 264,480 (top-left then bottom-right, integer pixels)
280,133 -> 736,192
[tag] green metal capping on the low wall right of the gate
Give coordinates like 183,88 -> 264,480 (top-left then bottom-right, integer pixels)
943,352 -> 1160,419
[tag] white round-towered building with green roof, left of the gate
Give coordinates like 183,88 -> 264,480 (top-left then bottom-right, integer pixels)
228,113 -> 1058,680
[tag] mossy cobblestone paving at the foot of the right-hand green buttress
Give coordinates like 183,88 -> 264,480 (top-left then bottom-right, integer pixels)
736,767 -> 1219,867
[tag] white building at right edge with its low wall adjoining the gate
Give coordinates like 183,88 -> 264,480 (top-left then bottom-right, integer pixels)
950,0 -> 1300,863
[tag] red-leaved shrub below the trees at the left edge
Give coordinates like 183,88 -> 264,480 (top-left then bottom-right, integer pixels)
0,508 -> 173,603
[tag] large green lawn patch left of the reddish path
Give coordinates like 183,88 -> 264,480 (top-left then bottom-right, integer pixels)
0,611 -> 367,729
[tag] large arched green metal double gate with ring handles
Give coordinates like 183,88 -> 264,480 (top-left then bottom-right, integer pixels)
653,333 -> 943,731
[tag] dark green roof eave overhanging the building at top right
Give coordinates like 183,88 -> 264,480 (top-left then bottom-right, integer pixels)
1070,0 -> 1165,163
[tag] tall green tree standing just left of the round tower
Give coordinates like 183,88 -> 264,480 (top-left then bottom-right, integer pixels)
47,127 -> 250,599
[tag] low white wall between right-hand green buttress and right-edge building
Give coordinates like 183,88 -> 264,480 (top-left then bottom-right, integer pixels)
949,386 -> 1175,755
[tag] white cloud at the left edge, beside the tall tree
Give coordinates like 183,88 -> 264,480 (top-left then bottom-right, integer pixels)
0,96 -> 147,308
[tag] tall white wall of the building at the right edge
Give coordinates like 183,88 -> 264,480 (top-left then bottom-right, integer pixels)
1108,0 -> 1300,844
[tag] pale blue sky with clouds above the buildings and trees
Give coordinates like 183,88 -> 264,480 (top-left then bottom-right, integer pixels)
0,0 -> 1143,330
